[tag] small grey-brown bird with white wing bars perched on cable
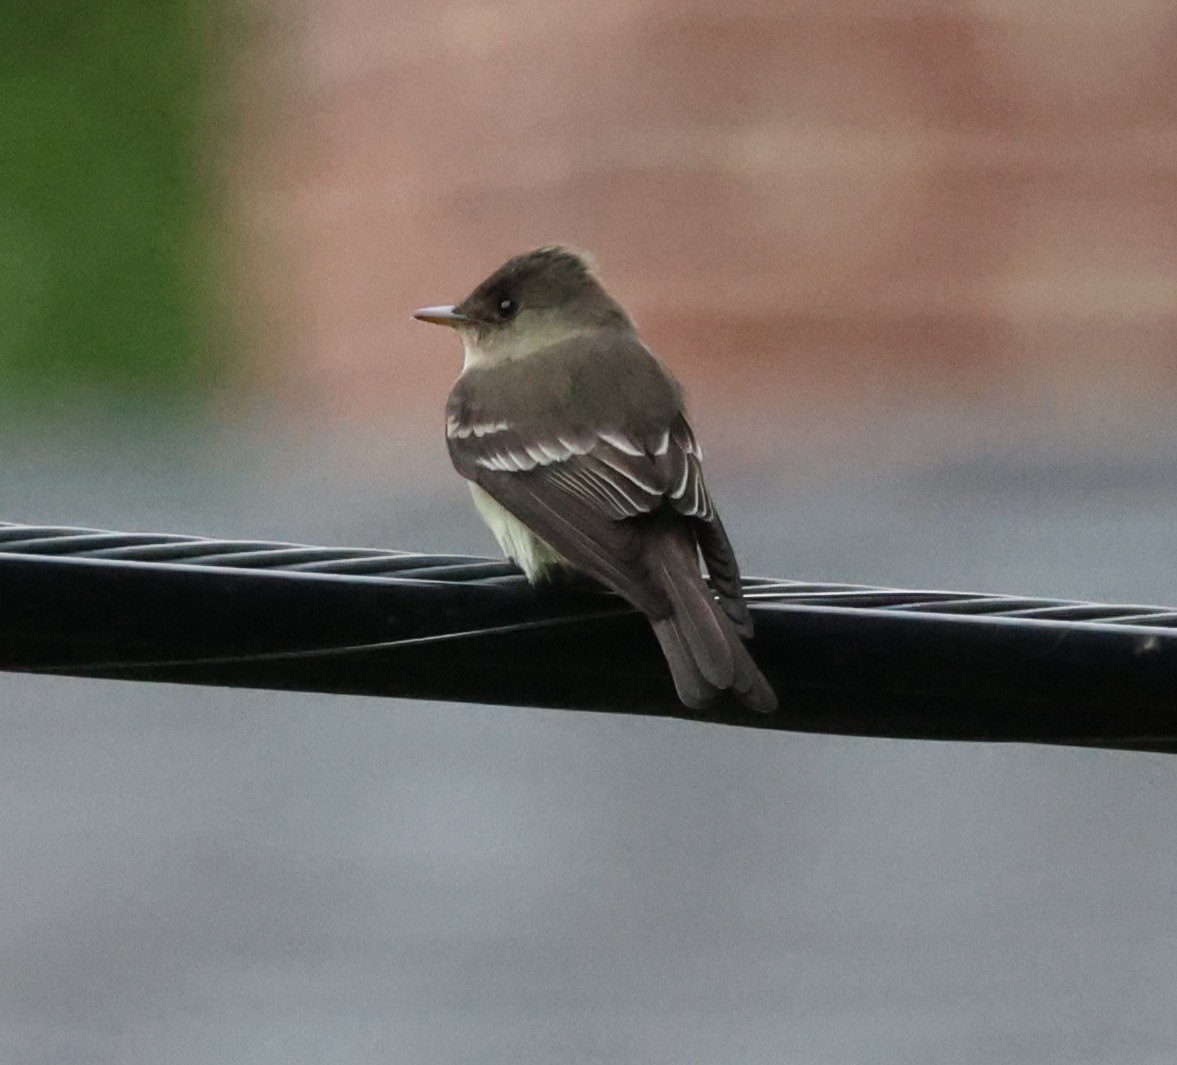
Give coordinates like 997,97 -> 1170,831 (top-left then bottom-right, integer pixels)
414,246 -> 777,712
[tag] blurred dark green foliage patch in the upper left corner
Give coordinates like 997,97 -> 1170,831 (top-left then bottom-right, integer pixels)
0,0 -> 214,395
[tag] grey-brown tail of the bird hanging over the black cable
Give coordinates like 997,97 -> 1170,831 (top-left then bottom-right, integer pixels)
646,534 -> 777,713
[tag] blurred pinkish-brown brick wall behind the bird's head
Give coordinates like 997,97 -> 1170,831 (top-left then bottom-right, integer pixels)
228,0 -> 1177,437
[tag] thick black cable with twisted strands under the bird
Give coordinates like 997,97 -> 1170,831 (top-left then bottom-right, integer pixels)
0,524 -> 1177,751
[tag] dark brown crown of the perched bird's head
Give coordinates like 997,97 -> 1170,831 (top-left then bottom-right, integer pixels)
457,245 -> 630,328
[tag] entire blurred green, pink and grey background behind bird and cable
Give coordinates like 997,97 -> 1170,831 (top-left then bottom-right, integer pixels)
0,0 -> 1177,1065
